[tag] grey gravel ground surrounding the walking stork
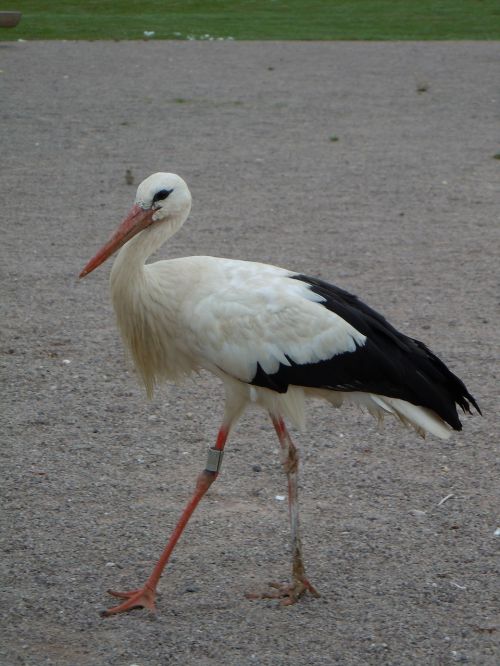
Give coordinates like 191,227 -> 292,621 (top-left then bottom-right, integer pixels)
0,42 -> 500,666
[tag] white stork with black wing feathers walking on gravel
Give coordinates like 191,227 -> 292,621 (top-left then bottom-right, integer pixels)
80,172 -> 481,616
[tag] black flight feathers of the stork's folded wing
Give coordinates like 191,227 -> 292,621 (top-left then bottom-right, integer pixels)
251,275 -> 481,430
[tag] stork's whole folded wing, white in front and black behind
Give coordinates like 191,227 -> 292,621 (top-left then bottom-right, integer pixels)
185,264 -> 478,428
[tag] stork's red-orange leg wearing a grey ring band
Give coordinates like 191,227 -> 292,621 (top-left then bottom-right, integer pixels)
102,425 -> 229,617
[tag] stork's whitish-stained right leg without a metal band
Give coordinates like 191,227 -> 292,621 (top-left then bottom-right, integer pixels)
247,414 -> 320,605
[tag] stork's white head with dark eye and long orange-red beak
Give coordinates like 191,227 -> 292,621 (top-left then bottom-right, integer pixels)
80,173 -> 191,277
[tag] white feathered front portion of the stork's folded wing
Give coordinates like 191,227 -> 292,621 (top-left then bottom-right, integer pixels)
189,262 -> 366,378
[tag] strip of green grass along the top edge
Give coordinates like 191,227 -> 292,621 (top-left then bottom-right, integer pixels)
0,0 -> 500,40
